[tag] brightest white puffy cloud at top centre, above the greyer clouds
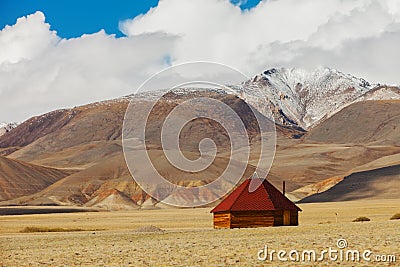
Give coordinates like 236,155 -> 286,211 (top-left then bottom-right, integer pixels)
121,0 -> 347,67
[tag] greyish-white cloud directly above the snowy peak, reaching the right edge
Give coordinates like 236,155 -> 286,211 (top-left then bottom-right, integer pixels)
245,1 -> 400,82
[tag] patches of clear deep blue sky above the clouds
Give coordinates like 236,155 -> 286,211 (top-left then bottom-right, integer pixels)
0,0 -> 260,38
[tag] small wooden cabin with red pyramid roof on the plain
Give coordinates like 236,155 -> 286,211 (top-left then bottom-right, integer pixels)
211,178 -> 301,228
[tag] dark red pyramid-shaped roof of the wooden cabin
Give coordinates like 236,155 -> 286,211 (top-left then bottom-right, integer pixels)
211,178 -> 301,215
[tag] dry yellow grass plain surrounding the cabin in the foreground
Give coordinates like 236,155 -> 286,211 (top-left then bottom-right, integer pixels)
0,200 -> 400,266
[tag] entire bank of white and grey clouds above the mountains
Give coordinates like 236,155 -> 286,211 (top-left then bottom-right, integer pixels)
0,0 -> 400,121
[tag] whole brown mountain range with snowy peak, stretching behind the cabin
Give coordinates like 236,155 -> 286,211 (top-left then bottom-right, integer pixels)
0,68 -> 400,209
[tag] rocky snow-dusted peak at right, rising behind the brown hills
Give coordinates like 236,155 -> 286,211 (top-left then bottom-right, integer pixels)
238,68 -> 373,129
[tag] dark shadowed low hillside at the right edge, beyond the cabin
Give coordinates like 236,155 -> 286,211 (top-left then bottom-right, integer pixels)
300,165 -> 400,203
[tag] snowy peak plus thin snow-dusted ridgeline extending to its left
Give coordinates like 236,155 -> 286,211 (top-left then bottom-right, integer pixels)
7,68 -> 400,140
